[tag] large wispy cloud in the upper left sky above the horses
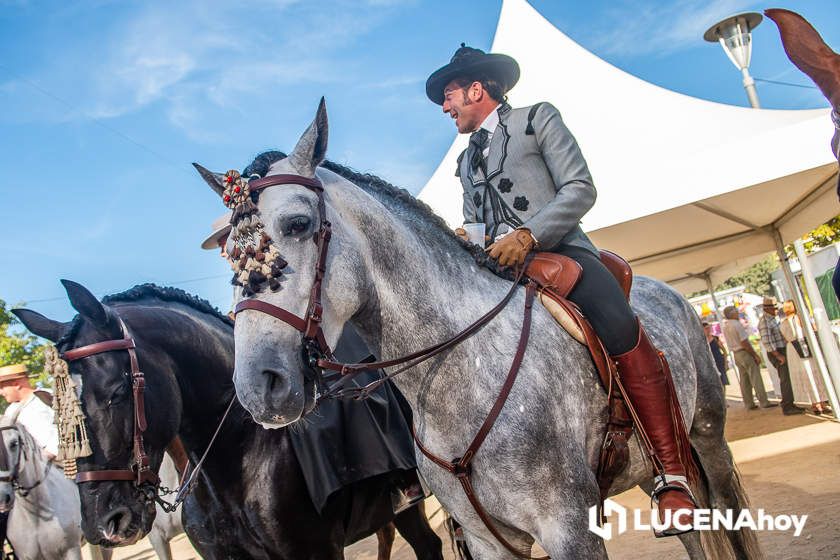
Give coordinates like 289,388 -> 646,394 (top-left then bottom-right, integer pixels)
7,0 -> 405,140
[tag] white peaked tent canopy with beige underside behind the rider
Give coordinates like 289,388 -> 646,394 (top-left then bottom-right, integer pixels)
419,0 -> 837,291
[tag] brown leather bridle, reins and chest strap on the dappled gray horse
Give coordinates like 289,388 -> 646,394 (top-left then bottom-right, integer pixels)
234,175 -> 549,560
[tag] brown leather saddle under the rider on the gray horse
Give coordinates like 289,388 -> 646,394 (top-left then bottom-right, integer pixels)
525,251 -> 633,503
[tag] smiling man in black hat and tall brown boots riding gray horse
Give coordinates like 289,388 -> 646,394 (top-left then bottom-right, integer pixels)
426,43 -> 697,536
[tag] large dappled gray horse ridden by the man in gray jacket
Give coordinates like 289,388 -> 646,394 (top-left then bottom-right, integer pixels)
197,100 -> 759,560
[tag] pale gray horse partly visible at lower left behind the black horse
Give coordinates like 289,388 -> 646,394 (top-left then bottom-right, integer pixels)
0,418 -> 111,560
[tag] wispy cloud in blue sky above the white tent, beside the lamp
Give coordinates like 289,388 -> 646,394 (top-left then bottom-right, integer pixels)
592,0 -> 756,56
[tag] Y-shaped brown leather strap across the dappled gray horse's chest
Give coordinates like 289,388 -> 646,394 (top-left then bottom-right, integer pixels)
411,282 -> 549,560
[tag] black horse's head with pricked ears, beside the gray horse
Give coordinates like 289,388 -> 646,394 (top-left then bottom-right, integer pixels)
14,280 -> 181,546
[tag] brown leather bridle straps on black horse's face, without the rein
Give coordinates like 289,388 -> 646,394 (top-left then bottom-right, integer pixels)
61,318 -> 159,486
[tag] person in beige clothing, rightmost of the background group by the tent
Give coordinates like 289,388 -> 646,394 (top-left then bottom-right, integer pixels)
779,300 -> 831,414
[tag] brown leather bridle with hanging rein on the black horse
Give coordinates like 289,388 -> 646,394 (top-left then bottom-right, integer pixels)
61,312 -> 236,512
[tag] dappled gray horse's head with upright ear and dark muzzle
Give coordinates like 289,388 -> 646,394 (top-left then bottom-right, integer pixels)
196,99 -> 366,427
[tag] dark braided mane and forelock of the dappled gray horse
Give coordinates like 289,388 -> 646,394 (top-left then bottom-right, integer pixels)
242,150 -> 513,279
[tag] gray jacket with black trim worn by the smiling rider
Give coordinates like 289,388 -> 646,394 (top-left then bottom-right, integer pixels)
455,103 -> 598,255
